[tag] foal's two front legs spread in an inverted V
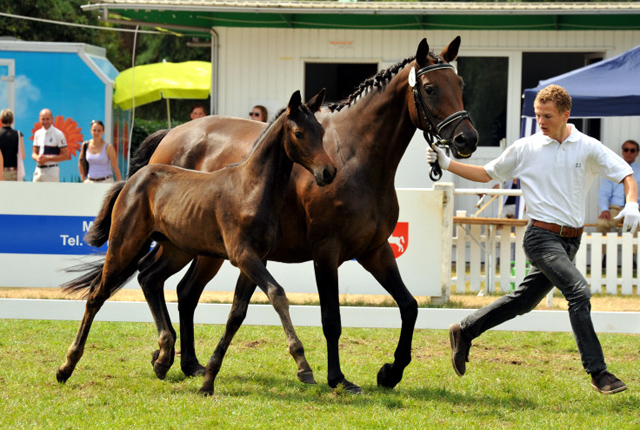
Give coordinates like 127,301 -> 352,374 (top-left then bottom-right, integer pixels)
200,257 -> 315,395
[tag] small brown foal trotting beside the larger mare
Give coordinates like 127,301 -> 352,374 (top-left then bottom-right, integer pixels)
56,90 -> 336,394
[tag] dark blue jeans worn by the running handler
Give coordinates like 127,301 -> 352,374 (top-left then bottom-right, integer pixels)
460,226 -> 607,373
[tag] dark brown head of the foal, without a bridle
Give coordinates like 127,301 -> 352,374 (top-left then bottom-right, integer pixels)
283,89 -> 337,187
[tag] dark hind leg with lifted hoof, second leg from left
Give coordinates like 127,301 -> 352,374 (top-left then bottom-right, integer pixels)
138,242 -> 192,379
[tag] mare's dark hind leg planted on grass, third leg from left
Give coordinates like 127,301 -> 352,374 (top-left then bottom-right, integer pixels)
177,256 -> 224,376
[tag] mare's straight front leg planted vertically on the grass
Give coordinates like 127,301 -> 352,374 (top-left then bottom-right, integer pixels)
313,250 -> 362,394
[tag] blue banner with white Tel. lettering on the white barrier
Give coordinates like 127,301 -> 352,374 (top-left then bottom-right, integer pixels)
0,214 -> 107,255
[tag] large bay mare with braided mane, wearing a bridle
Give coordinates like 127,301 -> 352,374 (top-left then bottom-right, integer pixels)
126,37 -> 478,393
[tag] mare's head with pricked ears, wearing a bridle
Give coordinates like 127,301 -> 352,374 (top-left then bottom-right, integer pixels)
409,36 -> 478,158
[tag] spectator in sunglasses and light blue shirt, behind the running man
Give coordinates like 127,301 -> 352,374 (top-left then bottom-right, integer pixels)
596,140 -> 640,237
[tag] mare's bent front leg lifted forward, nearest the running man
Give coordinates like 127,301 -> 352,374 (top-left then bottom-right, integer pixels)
357,243 -> 418,388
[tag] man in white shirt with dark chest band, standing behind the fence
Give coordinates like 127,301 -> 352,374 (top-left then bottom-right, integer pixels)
31,109 -> 70,182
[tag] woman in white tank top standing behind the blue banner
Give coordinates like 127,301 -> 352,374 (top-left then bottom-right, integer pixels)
78,120 -> 122,183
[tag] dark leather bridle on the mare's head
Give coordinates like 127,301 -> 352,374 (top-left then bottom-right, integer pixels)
409,63 -> 471,182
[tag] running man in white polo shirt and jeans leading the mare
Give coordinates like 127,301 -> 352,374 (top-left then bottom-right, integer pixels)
427,85 -> 640,394
